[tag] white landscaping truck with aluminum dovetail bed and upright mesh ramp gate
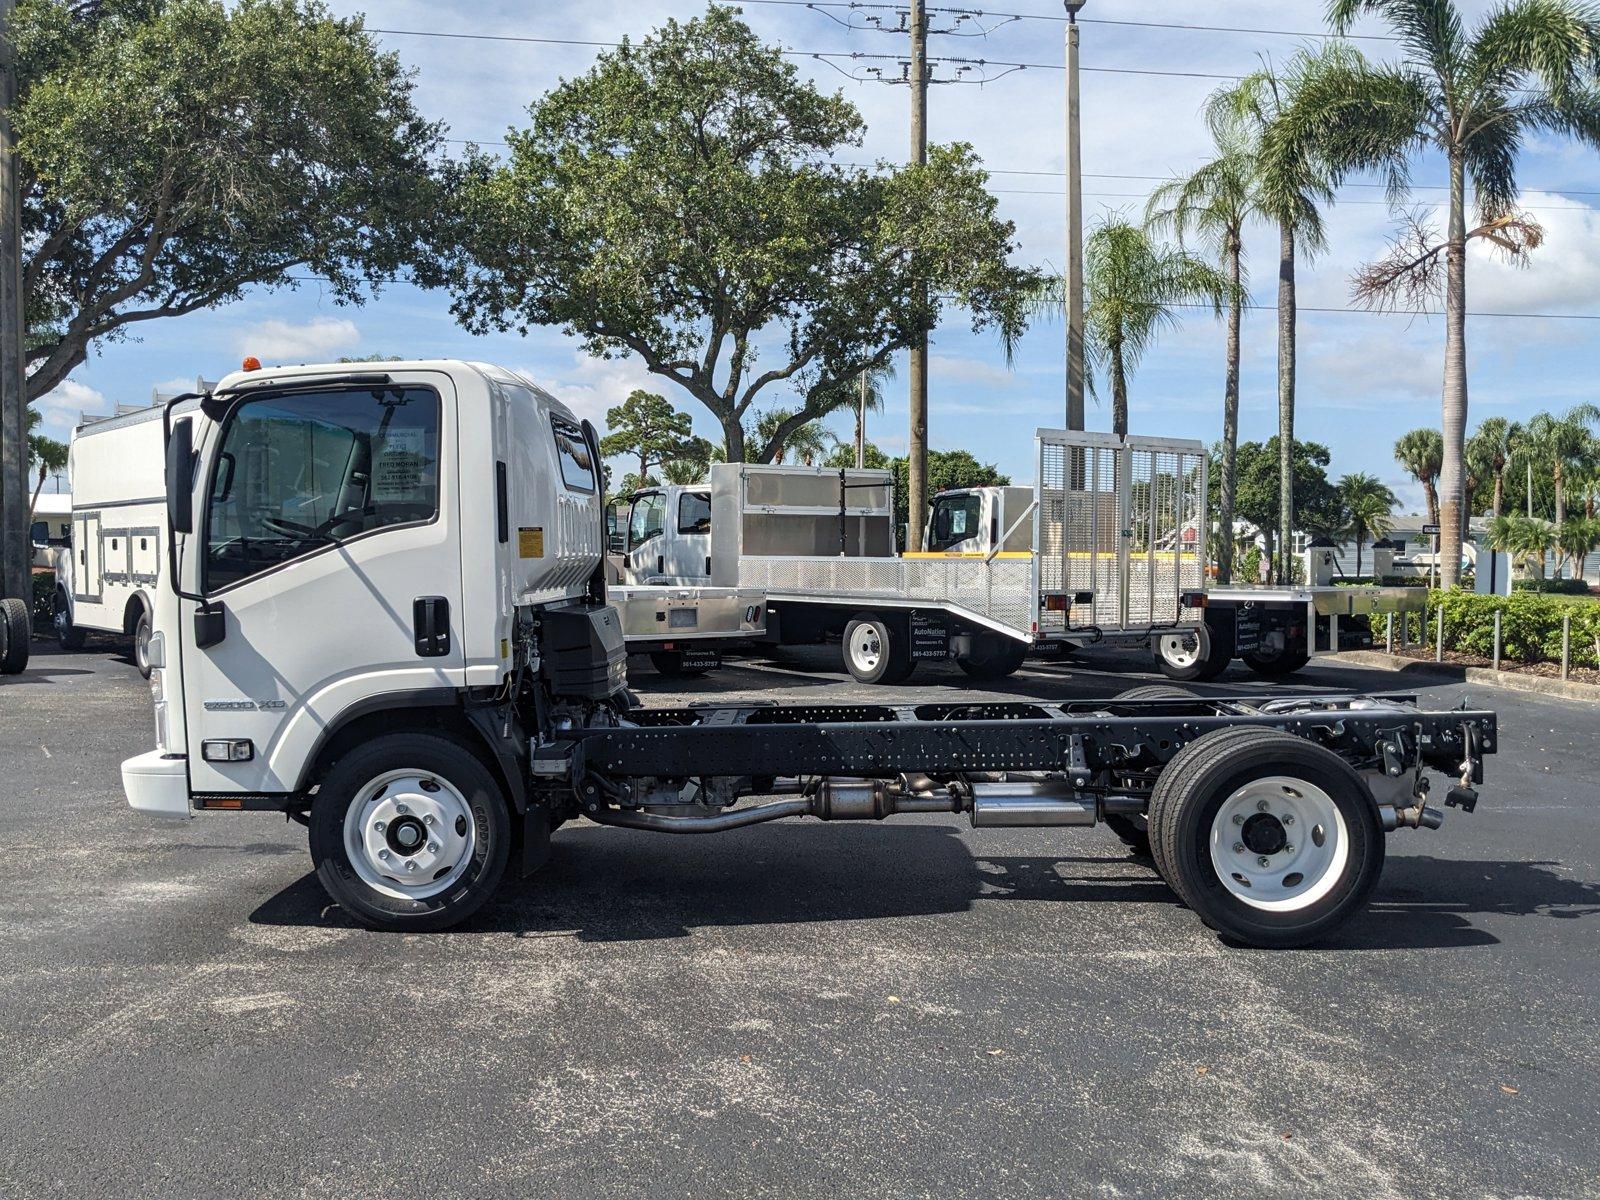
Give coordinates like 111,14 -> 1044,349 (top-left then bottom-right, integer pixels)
604,429 -> 1206,683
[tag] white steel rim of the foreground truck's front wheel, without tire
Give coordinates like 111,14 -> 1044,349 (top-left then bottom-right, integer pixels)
344,766 -> 478,901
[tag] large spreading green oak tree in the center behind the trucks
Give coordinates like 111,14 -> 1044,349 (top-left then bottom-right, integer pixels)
450,6 -> 1032,461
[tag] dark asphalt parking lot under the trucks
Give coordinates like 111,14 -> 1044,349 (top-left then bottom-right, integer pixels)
0,633 -> 1600,1197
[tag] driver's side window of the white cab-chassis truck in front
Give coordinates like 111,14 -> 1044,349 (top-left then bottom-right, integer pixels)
205,387 -> 438,590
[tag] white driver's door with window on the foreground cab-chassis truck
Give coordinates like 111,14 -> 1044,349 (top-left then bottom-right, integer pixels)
184,370 -> 467,794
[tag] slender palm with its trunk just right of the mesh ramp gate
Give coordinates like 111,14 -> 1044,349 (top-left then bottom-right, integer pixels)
1144,113 -> 1259,584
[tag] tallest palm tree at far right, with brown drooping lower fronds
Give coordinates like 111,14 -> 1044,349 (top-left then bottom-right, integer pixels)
1282,0 -> 1600,587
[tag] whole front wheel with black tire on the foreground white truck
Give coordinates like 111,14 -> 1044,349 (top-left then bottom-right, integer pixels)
310,733 -> 510,933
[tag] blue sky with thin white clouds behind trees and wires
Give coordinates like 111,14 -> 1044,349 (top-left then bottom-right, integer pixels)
40,0 -> 1600,507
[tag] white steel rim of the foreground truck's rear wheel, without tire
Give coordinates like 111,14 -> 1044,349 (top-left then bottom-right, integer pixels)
1211,774 -> 1350,912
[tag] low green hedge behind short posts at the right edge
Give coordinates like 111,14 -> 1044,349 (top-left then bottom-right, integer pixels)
1401,590 -> 1600,667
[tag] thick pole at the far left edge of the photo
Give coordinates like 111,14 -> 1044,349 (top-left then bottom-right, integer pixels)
0,0 -> 34,606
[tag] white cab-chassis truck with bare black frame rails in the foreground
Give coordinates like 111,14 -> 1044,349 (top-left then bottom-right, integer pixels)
122,362 -> 1498,946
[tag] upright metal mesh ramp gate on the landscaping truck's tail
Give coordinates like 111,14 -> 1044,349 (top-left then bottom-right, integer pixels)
1034,429 -> 1208,637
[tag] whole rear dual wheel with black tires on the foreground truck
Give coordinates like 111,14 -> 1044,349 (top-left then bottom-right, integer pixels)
1149,728 -> 1384,947
